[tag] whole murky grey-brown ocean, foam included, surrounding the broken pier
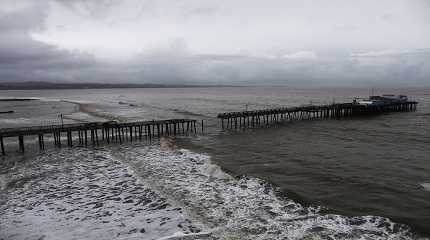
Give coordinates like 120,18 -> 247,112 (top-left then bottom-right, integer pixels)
0,87 -> 430,239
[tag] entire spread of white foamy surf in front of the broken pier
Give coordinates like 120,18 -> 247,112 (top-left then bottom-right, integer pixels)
0,139 -> 424,240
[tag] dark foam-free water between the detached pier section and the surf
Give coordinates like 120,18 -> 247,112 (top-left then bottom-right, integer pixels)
191,108 -> 430,234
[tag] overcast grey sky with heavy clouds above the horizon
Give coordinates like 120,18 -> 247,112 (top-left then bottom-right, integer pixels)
0,0 -> 430,86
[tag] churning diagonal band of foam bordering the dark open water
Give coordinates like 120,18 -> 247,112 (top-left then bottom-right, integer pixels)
114,142 -> 415,239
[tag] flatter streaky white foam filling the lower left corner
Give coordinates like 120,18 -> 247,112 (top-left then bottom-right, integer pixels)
0,149 -> 208,240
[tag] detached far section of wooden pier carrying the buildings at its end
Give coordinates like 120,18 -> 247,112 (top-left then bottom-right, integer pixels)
218,101 -> 418,129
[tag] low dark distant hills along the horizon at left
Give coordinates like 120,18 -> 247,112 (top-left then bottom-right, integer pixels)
0,82 -> 235,90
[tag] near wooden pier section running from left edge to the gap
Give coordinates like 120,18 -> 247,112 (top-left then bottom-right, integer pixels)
0,119 -> 197,155
